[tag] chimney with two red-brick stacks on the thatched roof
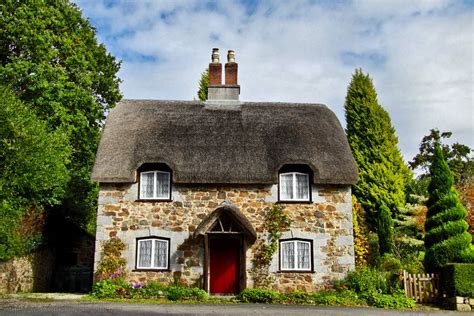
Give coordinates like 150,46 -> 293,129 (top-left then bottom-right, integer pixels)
207,48 -> 240,104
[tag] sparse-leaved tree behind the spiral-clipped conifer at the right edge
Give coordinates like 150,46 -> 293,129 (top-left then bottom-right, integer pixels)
409,128 -> 474,184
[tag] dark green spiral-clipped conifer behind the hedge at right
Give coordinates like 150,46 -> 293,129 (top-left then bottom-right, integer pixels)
424,143 -> 474,271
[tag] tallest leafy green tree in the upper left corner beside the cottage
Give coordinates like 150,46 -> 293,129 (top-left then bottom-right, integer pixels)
0,0 -> 121,232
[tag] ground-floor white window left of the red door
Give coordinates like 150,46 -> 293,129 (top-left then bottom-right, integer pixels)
137,238 -> 169,269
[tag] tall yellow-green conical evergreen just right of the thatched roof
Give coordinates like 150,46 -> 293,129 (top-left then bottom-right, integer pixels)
344,69 -> 411,231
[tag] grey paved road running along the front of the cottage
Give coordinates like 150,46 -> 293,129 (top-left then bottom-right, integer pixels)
0,299 -> 459,316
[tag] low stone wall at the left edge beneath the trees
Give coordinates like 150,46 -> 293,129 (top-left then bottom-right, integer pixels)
0,250 -> 54,294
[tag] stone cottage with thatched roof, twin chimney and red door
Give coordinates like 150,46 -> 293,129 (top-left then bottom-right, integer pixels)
92,49 -> 357,293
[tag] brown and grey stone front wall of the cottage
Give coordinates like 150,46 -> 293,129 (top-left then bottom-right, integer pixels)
95,183 -> 354,291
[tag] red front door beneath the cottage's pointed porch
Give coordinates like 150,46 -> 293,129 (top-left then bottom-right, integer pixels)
209,238 -> 240,294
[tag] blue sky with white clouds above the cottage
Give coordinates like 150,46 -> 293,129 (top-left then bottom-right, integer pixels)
75,0 -> 474,165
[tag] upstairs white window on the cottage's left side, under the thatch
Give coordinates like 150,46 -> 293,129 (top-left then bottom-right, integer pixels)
140,171 -> 171,200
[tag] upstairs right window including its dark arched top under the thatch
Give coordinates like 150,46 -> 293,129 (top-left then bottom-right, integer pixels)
278,165 -> 312,202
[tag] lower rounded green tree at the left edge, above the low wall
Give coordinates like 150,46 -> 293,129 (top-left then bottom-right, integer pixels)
0,86 -> 71,260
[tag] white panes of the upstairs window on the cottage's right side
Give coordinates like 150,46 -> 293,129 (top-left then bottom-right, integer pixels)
279,172 -> 310,201
